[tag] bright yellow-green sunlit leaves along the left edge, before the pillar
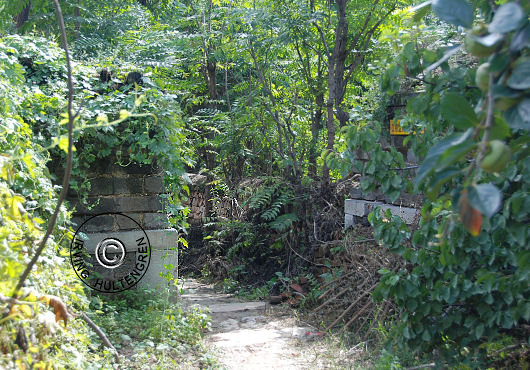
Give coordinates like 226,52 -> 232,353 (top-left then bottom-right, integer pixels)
0,33 -> 96,368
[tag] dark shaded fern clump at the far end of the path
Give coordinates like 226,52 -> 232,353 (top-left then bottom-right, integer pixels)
204,177 -> 298,281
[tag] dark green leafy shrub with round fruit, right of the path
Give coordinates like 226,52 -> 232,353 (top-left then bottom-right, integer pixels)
358,0 -> 530,367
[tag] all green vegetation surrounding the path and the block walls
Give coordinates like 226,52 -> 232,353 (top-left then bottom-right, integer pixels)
0,0 -> 530,368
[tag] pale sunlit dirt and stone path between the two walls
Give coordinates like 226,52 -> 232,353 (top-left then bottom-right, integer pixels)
177,280 -> 344,370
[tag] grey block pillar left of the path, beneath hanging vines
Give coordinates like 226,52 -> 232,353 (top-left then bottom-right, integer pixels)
64,155 -> 178,288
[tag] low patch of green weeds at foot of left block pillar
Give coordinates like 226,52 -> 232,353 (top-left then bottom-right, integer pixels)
87,290 -> 215,368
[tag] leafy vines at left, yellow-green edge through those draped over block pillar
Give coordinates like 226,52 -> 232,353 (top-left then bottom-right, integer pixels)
0,23 -> 192,368
